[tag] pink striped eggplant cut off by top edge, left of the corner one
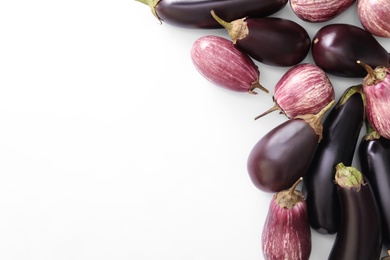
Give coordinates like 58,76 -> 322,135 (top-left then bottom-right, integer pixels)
290,0 -> 356,23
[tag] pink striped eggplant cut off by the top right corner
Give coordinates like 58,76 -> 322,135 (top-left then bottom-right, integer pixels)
357,0 -> 390,38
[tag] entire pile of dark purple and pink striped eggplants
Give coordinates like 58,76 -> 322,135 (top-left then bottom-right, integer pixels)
138,0 -> 390,260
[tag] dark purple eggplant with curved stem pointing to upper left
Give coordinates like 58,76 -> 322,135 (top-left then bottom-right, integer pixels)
211,10 -> 311,67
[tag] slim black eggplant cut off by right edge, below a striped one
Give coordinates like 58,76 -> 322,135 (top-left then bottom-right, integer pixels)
358,137 -> 390,249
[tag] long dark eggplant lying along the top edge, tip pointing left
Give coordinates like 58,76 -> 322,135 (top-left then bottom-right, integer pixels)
137,0 -> 288,29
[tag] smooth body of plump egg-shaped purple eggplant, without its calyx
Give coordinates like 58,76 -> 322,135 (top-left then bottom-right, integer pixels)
247,119 -> 318,192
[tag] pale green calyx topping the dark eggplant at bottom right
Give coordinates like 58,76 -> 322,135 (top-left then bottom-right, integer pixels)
335,162 -> 366,191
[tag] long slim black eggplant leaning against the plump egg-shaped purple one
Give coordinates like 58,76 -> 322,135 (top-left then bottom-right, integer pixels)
302,85 -> 365,234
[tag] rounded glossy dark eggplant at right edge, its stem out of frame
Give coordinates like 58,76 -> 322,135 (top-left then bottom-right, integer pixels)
311,24 -> 390,78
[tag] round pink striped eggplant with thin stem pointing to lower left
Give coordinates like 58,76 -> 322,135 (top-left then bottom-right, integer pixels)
255,63 -> 335,119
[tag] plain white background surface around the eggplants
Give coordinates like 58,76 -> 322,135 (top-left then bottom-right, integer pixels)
0,0 -> 390,260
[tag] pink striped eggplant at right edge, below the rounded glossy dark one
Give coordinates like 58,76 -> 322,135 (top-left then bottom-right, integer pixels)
363,68 -> 390,139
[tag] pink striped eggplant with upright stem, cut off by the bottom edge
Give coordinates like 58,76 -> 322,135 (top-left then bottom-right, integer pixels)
261,178 -> 311,260
